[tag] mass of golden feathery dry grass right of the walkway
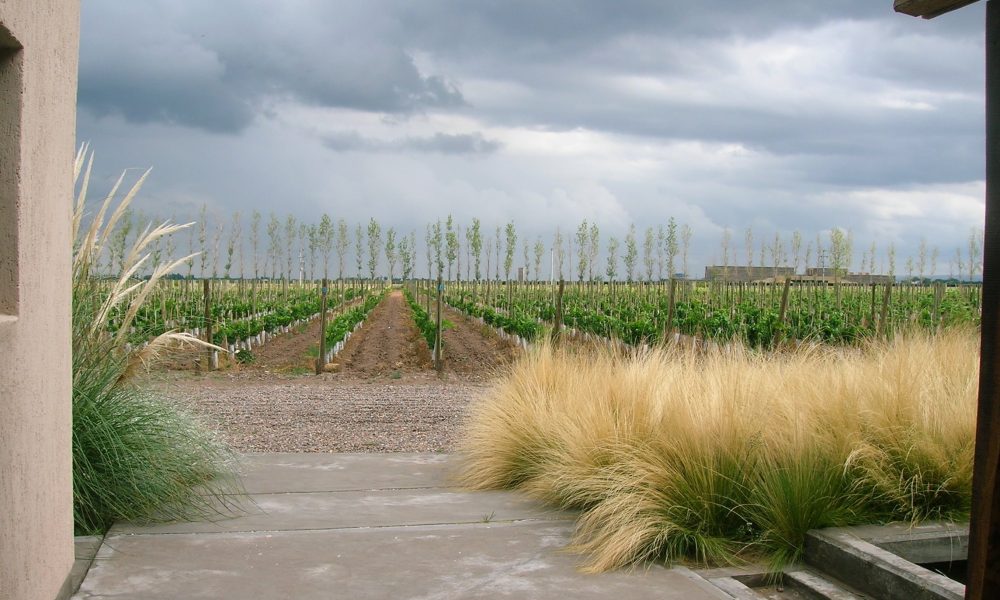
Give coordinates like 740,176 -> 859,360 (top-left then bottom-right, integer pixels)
462,331 -> 978,571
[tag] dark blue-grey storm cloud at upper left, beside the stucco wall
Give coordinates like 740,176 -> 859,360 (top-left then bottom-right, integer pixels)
79,0 -> 463,132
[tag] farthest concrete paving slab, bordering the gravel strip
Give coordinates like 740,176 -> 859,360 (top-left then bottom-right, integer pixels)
230,453 -> 458,494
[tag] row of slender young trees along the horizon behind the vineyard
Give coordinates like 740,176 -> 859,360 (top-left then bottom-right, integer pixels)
97,206 -> 983,282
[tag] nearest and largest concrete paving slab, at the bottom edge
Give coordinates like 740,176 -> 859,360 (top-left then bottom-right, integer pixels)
74,522 -> 726,600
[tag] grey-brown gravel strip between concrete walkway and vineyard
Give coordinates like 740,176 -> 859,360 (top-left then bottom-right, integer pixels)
157,375 -> 489,452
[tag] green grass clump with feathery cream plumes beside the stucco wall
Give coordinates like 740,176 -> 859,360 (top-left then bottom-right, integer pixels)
72,147 -> 239,534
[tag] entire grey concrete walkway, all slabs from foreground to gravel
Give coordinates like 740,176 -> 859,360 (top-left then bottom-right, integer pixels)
74,454 -> 726,600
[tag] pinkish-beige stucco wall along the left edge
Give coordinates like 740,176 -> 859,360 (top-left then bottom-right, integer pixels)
0,0 -> 80,600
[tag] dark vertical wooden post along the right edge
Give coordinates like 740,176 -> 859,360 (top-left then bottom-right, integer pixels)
966,0 -> 1000,600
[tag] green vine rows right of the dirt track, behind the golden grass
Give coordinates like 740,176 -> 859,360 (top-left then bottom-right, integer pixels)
438,280 -> 980,348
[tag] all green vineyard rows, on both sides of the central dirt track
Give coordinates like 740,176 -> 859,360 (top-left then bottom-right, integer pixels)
95,280 -> 980,372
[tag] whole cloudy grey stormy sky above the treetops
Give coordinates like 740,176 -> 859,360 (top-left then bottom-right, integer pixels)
77,0 -> 985,274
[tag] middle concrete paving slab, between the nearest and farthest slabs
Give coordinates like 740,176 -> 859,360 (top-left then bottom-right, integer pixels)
108,488 -> 575,536
